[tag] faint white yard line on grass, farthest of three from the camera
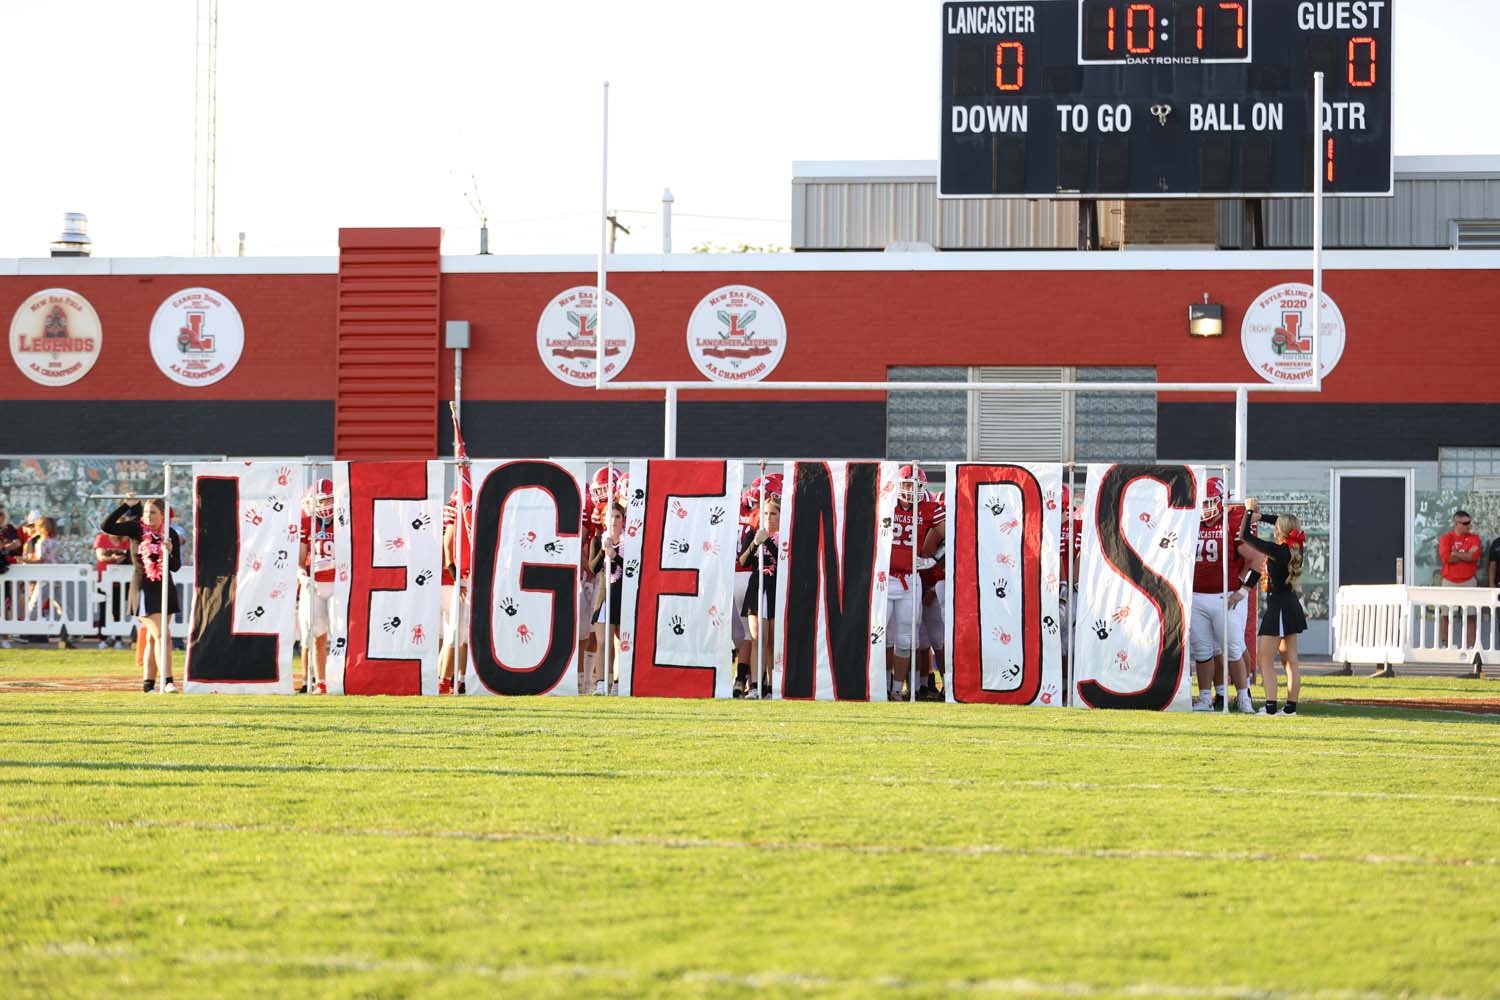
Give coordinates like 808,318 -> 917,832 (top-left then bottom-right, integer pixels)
0,755 -> 1500,805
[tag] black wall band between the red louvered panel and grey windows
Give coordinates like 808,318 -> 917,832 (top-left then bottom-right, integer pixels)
438,400 -> 885,459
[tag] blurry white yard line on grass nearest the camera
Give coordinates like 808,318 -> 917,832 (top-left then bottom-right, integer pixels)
41,942 -> 1434,1000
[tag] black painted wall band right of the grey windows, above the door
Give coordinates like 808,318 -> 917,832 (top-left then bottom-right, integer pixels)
1157,402 -> 1500,462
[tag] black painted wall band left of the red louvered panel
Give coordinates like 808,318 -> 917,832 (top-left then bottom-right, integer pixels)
0,399 -> 333,456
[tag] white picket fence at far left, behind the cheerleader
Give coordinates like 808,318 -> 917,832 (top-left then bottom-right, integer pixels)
0,564 -> 194,639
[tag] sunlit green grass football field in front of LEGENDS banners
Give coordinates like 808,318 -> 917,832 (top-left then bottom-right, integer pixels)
0,651 -> 1500,999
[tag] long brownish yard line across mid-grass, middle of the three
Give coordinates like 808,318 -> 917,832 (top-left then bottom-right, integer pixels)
11,816 -> 1500,868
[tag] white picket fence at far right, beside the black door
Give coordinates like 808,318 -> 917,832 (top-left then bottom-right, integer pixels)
1334,585 -> 1500,666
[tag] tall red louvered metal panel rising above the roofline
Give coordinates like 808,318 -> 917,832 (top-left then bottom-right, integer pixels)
333,229 -> 443,459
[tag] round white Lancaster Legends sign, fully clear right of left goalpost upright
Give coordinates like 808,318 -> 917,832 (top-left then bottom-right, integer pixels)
687,285 -> 786,382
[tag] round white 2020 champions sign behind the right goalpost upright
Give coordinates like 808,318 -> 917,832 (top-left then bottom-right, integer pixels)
1239,283 -> 1344,385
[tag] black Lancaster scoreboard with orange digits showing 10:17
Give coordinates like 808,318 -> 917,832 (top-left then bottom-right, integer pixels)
938,0 -> 1395,198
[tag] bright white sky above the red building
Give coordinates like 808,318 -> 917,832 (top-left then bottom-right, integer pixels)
0,0 -> 1500,258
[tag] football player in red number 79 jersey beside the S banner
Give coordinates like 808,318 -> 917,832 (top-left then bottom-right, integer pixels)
1188,475 -> 1260,714
